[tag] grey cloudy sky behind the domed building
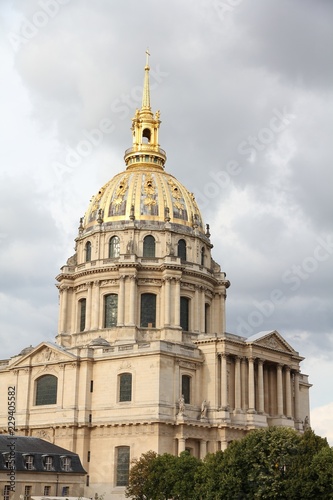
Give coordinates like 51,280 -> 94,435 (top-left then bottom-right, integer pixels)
0,0 -> 333,444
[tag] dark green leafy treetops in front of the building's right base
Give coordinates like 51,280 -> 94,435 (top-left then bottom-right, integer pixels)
126,427 -> 333,500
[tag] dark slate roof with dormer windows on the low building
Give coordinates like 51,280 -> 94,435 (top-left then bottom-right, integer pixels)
0,434 -> 86,474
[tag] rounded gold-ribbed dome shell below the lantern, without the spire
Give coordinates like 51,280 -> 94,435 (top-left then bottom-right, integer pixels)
84,164 -> 204,233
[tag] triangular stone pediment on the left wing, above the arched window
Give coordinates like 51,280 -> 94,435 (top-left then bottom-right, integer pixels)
11,342 -> 77,368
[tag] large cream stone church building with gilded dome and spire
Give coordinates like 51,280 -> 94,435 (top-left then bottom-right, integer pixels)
0,56 -> 310,499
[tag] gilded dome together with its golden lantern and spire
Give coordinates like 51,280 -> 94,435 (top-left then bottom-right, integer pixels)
84,51 -> 204,234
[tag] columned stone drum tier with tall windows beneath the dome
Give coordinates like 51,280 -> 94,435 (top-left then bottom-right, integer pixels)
59,273 -> 225,333
